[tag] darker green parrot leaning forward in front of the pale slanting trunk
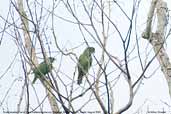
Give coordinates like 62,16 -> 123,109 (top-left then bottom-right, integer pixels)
32,57 -> 55,84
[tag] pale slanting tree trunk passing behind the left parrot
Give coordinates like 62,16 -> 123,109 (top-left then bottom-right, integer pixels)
18,0 -> 59,113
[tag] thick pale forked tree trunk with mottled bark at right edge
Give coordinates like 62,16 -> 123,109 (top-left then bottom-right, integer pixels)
142,0 -> 171,97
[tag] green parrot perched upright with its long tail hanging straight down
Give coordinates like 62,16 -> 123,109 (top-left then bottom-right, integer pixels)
77,47 -> 95,85
